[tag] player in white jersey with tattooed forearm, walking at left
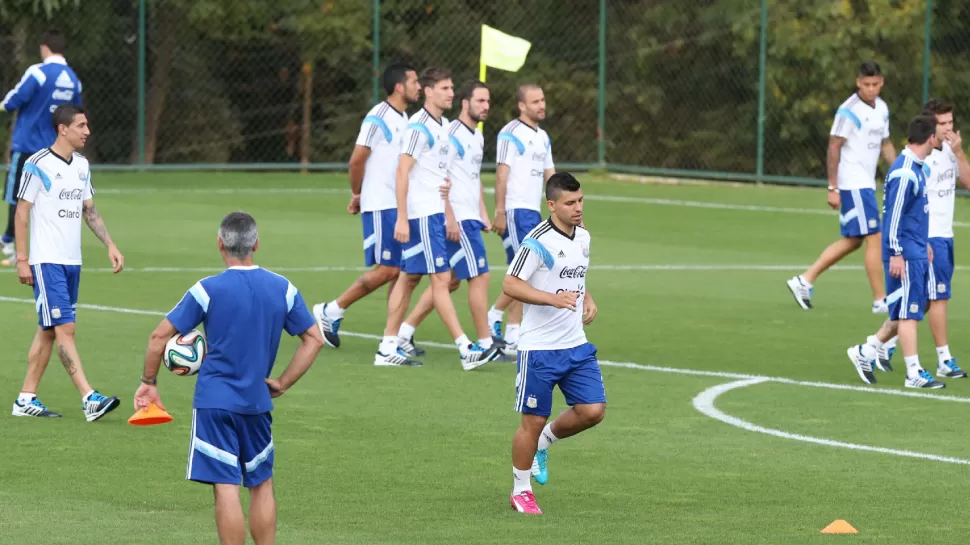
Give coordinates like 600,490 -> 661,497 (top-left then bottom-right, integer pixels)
13,104 -> 125,422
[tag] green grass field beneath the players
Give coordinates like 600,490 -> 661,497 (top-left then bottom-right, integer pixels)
0,173 -> 970,545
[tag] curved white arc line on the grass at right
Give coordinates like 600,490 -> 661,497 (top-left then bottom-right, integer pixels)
693,377 -> 970,465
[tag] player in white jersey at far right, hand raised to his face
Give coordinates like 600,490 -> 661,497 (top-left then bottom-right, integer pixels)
878,99 -> 970,378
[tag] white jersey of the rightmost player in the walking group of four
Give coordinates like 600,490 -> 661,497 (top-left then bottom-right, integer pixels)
496,119 -> 555,212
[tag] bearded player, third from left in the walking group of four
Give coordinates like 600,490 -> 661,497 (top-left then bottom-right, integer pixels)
398,80 -> 501,356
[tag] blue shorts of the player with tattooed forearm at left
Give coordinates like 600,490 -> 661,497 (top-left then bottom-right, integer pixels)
30,263 -> 81,329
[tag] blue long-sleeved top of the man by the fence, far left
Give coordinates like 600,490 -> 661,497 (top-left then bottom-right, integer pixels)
0,55 -> 81,154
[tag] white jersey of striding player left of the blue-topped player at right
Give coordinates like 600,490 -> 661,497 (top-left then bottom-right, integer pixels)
829,93 -> 889,190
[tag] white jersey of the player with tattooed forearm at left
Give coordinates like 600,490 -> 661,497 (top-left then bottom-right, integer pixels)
17,148 -> 94,265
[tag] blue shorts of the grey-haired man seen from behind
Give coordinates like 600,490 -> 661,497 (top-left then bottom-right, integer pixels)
185,409 -> 275,488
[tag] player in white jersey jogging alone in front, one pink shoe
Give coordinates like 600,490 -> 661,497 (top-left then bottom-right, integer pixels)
502,172 -> 606,514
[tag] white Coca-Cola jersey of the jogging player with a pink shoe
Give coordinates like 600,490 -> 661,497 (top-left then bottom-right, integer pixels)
506,219 -> 590,350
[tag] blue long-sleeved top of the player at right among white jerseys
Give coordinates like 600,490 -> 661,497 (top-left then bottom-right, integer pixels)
882,148 -> 930,261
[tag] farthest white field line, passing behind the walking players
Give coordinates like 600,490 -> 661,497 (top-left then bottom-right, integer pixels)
89,187 -> 970,227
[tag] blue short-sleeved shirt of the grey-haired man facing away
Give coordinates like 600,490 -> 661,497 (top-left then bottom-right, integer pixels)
167,266 -> 316,414
